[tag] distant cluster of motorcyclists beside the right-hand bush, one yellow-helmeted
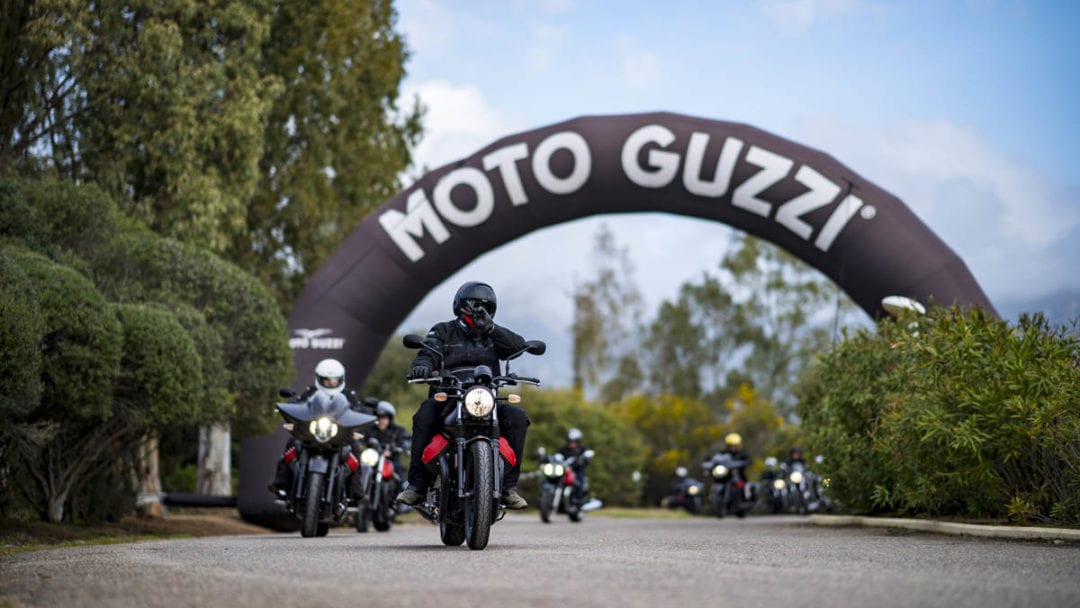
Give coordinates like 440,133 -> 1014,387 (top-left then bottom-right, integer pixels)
663,433 -> 832,517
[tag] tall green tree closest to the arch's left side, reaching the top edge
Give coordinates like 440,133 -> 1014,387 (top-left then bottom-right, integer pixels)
238,0 -> 422,303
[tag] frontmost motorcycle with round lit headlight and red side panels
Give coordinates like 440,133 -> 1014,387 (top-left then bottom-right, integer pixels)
403,335 -> 546,550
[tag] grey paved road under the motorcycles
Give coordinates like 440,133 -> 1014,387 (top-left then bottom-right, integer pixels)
0,515 -> 1080,608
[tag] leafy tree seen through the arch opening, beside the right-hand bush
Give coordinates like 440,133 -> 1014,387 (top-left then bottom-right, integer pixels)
645,234 -> 855,416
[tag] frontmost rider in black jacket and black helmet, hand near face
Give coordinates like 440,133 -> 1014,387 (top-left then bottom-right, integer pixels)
397,281 -> 529,509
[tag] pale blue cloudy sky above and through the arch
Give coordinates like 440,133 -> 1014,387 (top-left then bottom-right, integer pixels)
388,0 -> 1080,384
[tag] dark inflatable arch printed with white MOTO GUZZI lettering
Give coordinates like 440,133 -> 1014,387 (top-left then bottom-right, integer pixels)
239,112 -> 994,524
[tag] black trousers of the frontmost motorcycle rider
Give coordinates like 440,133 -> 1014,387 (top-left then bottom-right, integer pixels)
408,398 -> 530,490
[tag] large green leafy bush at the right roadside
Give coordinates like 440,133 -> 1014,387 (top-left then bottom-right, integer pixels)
799,308 -> 1080,524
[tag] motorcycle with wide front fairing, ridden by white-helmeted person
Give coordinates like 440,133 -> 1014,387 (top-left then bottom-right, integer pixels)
276,389 -> 376,538
